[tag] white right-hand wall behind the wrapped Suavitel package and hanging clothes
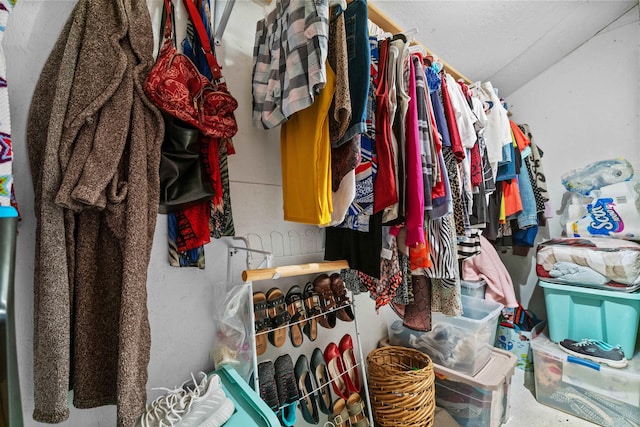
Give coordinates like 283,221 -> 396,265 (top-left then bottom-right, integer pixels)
502,6 -> 640,320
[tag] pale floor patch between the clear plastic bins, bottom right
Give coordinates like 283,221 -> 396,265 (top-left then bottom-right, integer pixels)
503,369 -> 597,427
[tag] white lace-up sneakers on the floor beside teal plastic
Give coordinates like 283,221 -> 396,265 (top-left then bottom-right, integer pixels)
136,372 -> 235,427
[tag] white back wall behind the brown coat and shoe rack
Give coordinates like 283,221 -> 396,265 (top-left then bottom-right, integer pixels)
4,0 -> 386,426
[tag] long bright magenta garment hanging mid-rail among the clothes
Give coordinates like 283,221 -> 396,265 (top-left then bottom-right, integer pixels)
405,61 -> 424,247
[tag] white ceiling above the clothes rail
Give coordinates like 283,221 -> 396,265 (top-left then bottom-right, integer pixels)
370,0 -> 638,97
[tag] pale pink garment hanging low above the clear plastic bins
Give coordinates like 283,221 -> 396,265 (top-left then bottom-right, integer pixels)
462,235 -> 518,307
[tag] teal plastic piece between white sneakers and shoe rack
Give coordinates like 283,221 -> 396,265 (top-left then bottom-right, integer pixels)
214,366 -> 280,427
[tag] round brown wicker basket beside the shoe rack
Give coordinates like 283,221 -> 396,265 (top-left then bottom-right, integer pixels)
367,346 -> 435,427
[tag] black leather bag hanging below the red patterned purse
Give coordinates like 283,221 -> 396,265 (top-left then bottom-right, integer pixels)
159,115 -> 215,213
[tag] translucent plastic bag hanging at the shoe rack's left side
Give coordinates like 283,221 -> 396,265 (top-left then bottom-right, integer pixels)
211,285 -> 253,381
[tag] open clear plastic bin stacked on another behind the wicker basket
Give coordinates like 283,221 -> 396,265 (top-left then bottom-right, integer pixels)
383,295 -> 502,375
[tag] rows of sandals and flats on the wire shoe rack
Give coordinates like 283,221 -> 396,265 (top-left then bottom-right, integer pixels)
251,273 -> 362,427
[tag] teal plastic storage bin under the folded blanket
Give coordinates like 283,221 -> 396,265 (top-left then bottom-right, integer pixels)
539,280 -> 640,359
